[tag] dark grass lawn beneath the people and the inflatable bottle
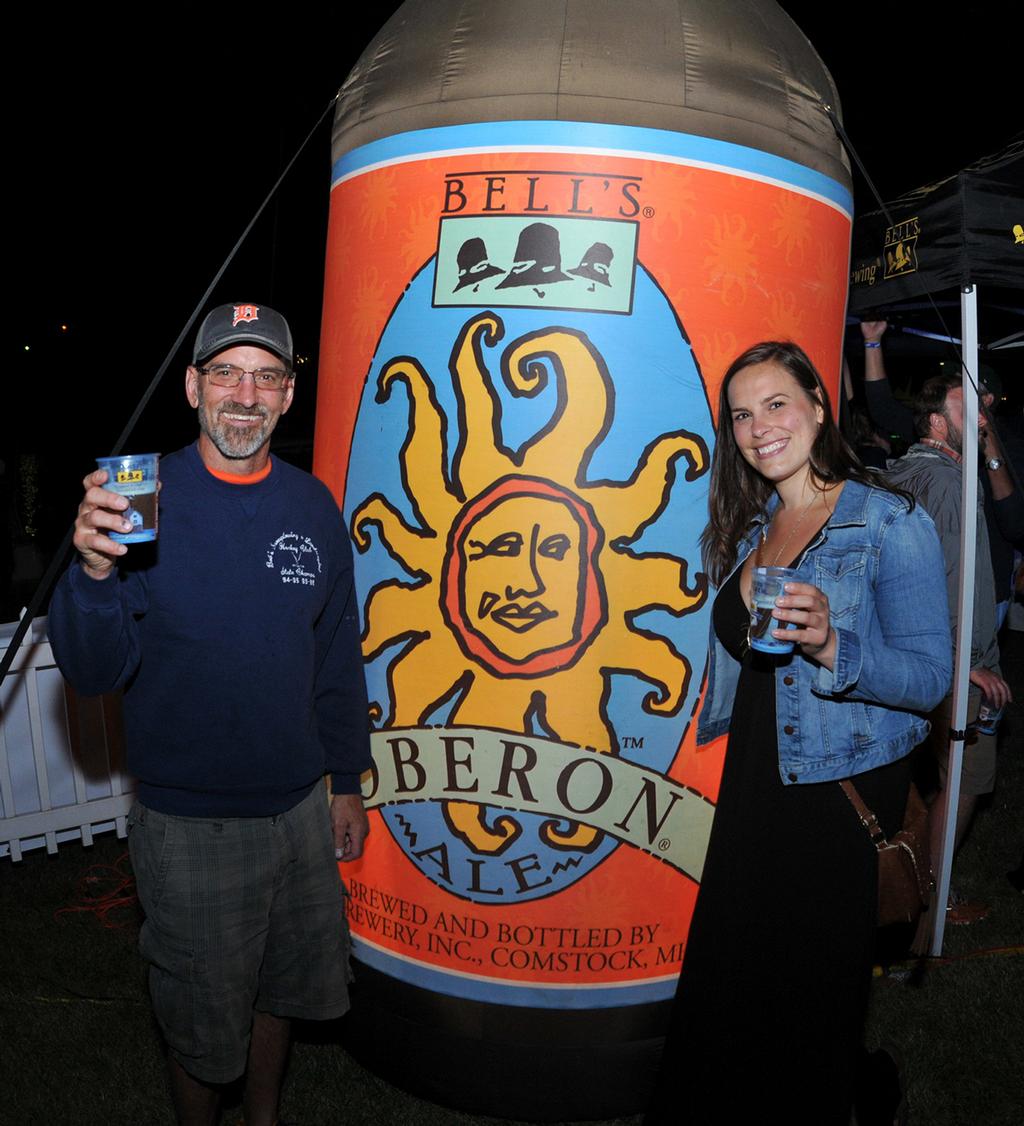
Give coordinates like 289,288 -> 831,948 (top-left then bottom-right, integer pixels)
0,634 -> 1024,1126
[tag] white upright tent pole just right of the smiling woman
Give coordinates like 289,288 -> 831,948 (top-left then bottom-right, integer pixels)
928,285 -> 977,957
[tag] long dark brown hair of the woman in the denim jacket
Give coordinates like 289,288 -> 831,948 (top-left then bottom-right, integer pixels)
701,340 -> 914,586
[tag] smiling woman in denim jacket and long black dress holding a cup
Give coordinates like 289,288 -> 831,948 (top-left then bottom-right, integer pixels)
647,342 -> 952,1126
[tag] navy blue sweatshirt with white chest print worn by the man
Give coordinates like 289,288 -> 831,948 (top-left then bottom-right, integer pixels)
48,446 -> 369,816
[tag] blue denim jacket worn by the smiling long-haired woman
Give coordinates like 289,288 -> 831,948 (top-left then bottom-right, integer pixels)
697,481 -> 953,784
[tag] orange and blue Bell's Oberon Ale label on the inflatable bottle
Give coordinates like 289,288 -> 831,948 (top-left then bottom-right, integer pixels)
315,122 -> 851,1008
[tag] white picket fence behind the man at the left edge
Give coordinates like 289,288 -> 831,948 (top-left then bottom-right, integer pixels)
0,618 -> 134,860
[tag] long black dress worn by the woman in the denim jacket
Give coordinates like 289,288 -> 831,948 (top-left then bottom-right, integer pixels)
645,564 -> 910,1126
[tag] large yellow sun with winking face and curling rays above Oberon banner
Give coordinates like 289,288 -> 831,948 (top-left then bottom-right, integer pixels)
351,313 -> 707,855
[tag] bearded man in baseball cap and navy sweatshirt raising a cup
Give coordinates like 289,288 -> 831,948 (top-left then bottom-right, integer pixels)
50,304 -> 369,1126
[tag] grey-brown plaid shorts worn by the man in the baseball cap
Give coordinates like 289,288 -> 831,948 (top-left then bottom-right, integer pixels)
128,785 -> 349,1083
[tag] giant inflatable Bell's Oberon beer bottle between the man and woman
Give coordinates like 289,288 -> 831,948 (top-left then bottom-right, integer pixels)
315,0 -> 851,1118
